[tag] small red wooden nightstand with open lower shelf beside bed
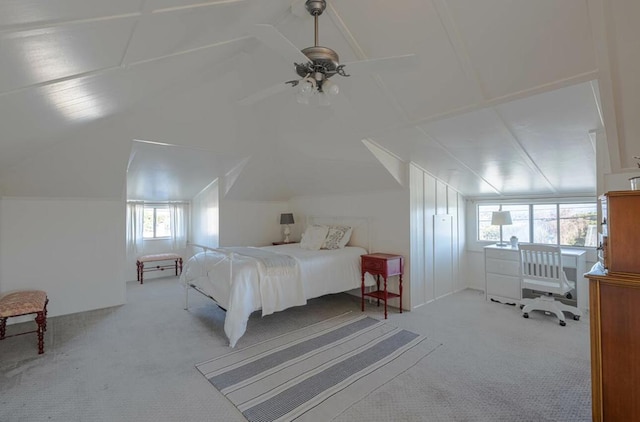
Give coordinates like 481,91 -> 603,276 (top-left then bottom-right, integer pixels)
360,253 -> 404,319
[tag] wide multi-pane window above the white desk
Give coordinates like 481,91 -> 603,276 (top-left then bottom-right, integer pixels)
478,202 -> 597,247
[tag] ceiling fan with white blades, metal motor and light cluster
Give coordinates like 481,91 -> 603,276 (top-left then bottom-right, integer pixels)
239,0 -> 416,105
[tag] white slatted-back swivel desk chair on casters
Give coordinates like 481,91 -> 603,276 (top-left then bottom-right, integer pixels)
519,245 -> 582,326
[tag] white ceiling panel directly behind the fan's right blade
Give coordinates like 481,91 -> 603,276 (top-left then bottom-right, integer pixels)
335,0 -> 479,120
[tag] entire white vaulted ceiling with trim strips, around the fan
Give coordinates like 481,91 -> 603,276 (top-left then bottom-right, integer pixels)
0,0 -> 640,200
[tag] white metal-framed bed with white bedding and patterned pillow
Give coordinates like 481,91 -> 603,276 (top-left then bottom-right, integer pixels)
180,217 -> 375,347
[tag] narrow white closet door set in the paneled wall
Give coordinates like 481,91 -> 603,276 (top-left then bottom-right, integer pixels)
433,214 -> 453,299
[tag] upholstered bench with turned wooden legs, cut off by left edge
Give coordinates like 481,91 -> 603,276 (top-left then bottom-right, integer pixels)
0,290 -> 49,354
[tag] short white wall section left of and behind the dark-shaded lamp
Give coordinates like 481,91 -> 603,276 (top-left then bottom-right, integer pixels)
220,199 -> 290,246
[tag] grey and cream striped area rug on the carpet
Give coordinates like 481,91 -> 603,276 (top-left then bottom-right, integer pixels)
196,313 -> 439,422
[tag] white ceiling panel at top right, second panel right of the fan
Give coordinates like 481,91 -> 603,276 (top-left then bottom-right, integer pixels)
446,0 -> 597,99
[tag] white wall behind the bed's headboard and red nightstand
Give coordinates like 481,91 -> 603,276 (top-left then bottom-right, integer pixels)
289,189 -> 411,309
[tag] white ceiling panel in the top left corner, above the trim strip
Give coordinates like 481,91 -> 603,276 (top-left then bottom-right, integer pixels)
0,0 -> 144,27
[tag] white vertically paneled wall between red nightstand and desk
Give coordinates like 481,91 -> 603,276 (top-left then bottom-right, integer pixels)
409,164 -> 467,307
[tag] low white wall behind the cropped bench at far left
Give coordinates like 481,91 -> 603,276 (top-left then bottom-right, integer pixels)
0,197 -> 125,316
